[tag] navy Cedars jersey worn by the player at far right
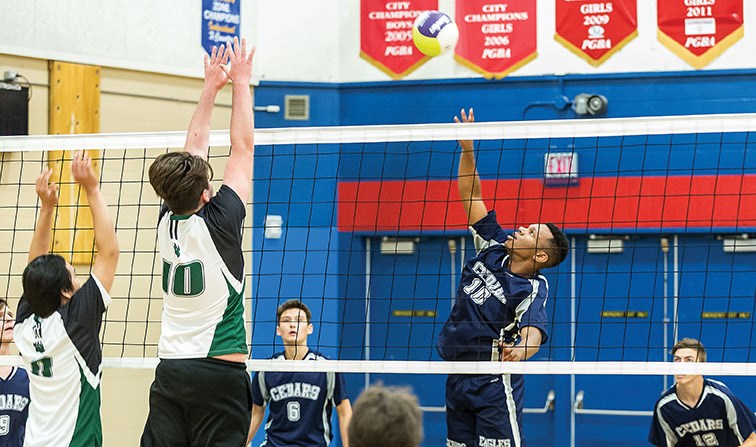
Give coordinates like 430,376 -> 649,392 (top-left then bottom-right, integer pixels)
648,378 -> 756,447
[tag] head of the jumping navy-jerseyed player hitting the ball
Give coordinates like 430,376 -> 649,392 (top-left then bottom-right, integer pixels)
504,222 -> 569,270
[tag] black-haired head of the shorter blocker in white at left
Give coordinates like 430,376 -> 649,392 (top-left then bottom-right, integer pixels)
21,254 -> 81,318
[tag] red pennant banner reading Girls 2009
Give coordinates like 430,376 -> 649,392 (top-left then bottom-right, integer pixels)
554,0 -> 638,67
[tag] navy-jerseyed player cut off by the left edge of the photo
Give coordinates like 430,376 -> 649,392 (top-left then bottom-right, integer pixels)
0,298 -> 29,447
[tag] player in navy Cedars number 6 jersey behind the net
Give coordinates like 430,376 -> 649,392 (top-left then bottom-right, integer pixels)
248,300 -> 352,447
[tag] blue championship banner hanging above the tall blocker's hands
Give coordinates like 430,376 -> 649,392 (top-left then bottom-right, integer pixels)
202,0 -> 241,54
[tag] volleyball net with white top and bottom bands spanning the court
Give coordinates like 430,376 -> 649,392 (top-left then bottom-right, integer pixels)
0,115 -> 756,375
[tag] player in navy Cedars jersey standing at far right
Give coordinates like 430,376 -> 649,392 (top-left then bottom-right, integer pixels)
648,338 -> 756,447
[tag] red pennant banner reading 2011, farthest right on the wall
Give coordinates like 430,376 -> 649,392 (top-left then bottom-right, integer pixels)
656,0 -> 743,68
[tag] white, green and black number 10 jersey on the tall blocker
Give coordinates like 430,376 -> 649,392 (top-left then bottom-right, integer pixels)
158,185 -> 247,359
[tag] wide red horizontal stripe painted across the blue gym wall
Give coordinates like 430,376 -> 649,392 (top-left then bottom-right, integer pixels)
338,175 -> 756,232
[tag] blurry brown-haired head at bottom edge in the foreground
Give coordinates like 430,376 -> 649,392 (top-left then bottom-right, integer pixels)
348,384 -> 423,447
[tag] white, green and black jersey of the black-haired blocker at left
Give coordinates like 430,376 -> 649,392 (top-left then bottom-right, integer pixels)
14,275 -> 110,447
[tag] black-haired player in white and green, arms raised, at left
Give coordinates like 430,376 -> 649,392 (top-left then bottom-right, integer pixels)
14,152 -> 120,447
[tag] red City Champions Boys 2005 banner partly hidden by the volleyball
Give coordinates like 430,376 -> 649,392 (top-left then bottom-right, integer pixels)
360,0 -> 438,79
